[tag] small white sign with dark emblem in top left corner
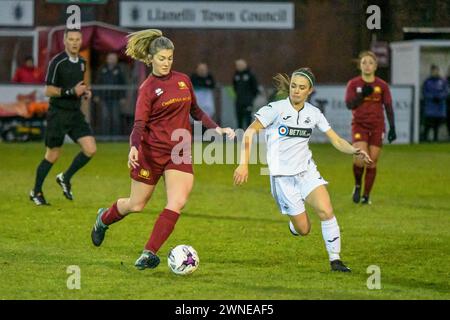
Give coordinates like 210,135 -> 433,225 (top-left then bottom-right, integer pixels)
0,0 -> 34,27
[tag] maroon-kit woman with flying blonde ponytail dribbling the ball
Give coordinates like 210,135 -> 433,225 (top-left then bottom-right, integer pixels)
91,29 -> 234,270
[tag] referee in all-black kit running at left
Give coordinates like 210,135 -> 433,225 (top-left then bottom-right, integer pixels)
30,29 -> 97,206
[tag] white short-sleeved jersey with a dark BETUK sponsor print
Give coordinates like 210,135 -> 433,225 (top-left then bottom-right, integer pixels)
255,98 -> 331,176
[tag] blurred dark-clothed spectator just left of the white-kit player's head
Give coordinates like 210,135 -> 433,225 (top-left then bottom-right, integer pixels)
233,59 -> 258,128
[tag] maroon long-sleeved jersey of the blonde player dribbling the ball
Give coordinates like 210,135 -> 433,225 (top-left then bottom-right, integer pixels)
130,71 -> 218,152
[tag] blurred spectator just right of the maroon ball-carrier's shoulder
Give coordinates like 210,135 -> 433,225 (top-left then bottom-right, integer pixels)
191,62 -> 216,118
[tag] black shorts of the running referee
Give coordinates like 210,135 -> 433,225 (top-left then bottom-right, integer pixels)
45,108 -> 93,148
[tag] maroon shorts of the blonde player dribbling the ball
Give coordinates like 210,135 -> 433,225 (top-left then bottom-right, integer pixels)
130,145 -> 194,185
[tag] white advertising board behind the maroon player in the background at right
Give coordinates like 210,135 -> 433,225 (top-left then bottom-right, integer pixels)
310,85 -> 413,143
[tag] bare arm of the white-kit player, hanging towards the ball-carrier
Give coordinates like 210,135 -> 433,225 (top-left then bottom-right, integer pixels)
233,119 -> 264,185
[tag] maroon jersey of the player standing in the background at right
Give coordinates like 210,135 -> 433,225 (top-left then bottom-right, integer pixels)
345,76 -> 392,128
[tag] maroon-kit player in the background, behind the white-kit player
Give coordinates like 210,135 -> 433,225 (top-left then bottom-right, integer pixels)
345,51 -> 397,204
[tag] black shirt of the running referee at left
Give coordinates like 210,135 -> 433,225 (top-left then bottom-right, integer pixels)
45,51 -> 86,110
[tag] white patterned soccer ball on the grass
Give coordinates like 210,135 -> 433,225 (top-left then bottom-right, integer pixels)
167,244 -> 200,275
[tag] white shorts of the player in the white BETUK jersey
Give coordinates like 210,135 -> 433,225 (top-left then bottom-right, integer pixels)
270,159 -> 328,216
